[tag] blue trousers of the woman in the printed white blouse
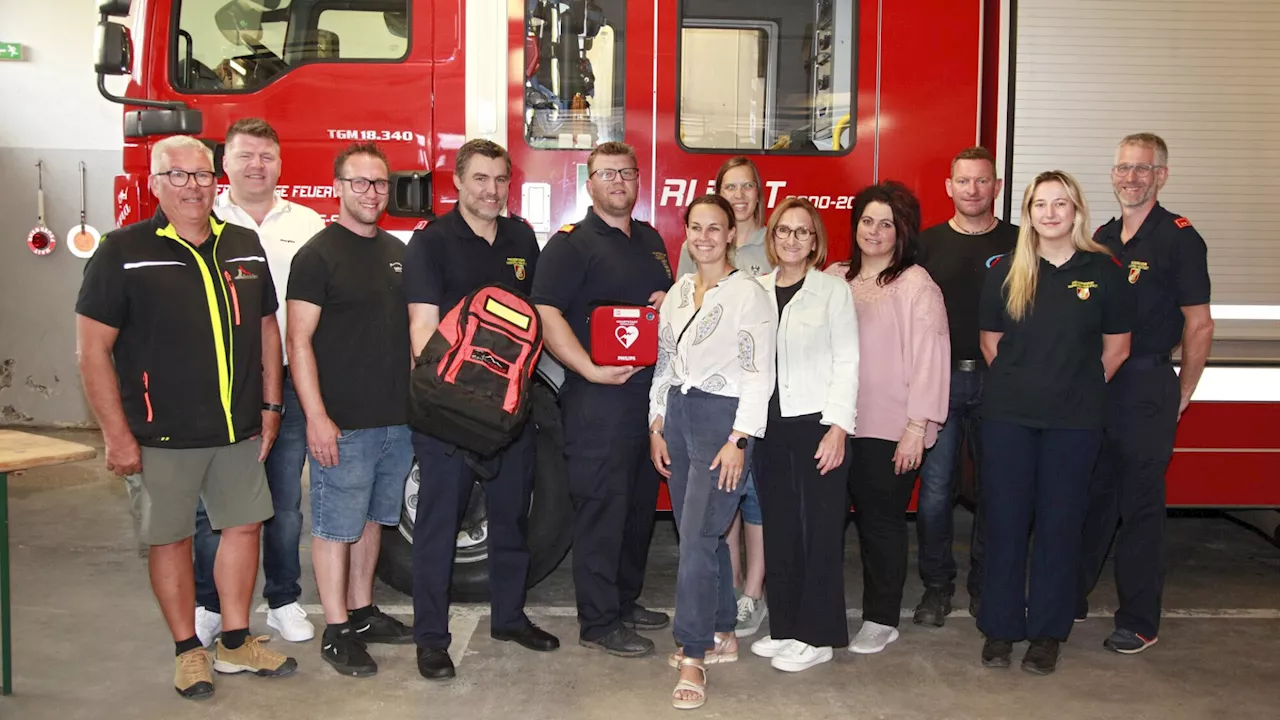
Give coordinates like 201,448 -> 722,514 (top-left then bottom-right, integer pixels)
663,389 -> 753,657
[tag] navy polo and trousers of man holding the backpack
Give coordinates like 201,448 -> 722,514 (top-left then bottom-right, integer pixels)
404,209 -> 539,650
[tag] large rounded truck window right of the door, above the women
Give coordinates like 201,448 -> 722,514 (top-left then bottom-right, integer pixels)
677,0 -> 858,154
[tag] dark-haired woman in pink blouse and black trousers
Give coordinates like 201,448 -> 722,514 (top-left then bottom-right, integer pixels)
827,182 -> 951,655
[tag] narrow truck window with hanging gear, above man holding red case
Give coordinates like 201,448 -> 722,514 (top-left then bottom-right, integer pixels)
524,0 -> 626,150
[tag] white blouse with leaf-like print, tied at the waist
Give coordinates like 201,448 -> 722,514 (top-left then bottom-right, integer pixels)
649,272 -> 778,437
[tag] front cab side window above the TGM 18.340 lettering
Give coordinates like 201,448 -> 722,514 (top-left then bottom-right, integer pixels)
170,0 -> 408,92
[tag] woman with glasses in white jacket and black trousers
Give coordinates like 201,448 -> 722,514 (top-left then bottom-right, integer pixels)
751,197 -> 858,673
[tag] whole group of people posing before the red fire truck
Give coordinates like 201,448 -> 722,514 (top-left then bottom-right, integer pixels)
76,118 -> 1212,708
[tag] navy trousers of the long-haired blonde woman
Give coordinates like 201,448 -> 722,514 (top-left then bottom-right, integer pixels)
978,419 -> 1102,642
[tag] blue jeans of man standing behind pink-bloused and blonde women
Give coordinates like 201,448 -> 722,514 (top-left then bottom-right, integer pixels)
915,370 -> 983,597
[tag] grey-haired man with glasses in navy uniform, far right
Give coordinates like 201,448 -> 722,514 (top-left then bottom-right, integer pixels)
1075,128 -> 1213,655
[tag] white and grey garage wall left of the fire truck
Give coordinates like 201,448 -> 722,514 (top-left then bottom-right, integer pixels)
0,3 -> 122,425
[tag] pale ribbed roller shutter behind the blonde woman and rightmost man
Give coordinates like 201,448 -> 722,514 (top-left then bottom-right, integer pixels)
1007,0 -> 1280,341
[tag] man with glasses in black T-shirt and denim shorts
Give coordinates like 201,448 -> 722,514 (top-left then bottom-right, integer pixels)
287,142 -> 413,678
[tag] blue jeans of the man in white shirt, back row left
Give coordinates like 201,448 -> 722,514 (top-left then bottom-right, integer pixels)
192,378 -> 307,612
